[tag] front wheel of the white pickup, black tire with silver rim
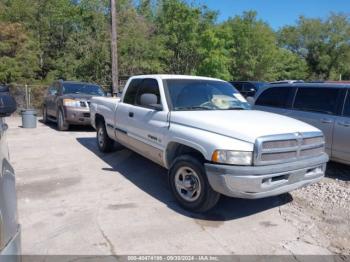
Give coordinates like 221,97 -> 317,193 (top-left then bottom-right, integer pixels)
169,155 -> 220,213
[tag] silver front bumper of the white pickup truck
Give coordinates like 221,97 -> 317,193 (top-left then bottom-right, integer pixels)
205,154 -> 328,199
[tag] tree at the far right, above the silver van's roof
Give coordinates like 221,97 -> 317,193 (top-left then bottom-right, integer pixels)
279,14 -> 350,79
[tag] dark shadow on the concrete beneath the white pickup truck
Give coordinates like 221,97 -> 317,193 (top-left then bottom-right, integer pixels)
77,137 -> 293,222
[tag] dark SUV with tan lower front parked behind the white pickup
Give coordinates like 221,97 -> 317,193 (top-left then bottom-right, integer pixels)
43,80 -> 106,131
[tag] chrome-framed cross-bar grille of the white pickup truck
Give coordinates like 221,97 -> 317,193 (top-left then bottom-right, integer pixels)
254,132 -> 325,165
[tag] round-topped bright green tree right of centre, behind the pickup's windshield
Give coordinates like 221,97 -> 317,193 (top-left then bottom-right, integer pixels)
223,11 -> 278,80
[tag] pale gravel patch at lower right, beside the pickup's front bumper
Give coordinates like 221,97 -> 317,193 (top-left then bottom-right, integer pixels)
280,163 -> 350,254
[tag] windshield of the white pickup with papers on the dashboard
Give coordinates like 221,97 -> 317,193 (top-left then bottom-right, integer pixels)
164,79 -> 251,111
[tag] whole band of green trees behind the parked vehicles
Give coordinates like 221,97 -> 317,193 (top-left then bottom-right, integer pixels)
0,0 -> 350,85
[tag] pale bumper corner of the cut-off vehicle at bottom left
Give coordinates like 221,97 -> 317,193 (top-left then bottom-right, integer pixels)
0,226 -> 21,262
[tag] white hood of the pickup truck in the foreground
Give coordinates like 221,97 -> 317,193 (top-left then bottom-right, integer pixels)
170,110 -> 320,143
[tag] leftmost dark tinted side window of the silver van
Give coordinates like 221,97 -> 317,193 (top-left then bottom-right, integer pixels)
255,86 -> 292,108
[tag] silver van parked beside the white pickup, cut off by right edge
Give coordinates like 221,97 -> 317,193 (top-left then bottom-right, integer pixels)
254,83 -> 350,165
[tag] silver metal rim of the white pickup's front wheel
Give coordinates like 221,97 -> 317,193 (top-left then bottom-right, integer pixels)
175,167 -> 201,202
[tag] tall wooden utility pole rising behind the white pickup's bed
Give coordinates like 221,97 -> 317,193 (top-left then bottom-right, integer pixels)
111,0 -> 119,94
